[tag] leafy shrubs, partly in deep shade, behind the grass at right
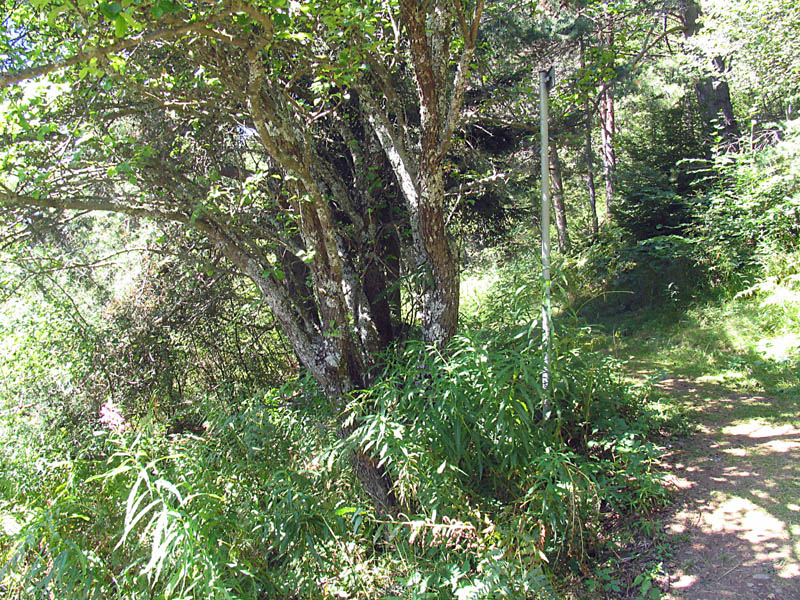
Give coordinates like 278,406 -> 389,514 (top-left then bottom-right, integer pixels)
565,115 -> 800,314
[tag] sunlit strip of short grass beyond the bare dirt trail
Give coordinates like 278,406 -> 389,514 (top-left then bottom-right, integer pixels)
605,278 -> 800,406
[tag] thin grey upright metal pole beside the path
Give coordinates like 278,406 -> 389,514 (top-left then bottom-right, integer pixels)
539,67 -> 554,412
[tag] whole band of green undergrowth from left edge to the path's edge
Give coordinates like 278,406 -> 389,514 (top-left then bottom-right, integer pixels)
0,250 -> 664,599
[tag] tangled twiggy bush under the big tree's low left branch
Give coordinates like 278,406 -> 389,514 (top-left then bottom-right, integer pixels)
0,215 -> 297,439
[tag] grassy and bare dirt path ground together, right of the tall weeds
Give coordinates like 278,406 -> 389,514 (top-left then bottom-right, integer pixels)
606,301 -> 800,600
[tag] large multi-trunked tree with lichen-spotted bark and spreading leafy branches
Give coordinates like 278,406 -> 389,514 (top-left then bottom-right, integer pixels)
0,0 -> 483,510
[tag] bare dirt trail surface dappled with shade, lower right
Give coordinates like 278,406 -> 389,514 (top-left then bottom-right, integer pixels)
659,379 -> 800,600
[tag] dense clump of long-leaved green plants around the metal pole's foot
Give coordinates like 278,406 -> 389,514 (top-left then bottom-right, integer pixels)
350,264 -> 660,557
